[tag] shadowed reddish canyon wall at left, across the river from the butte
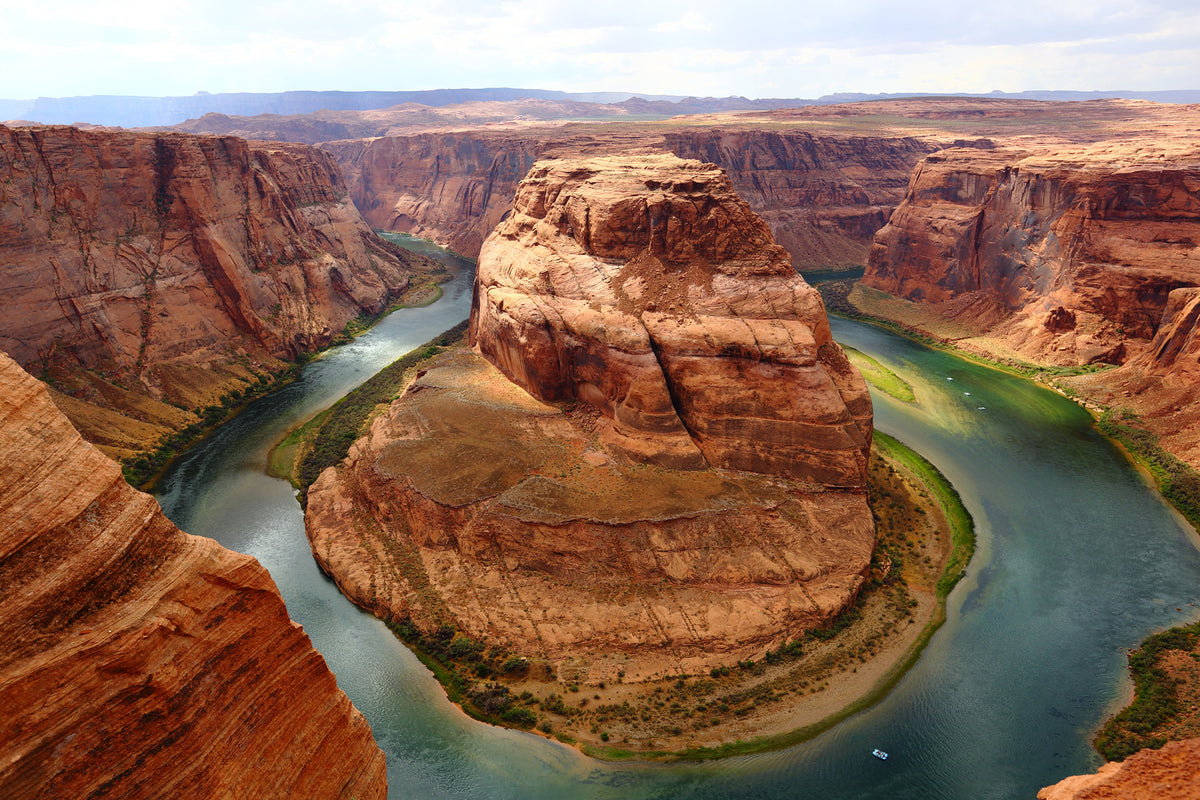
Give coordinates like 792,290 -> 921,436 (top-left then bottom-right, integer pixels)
0,127 -> 432,456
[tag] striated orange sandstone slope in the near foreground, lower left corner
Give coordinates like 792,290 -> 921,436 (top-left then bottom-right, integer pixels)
0,354 -> 386,800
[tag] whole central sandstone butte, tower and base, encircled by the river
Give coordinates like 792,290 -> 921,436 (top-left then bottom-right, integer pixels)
306,156 -> 874,681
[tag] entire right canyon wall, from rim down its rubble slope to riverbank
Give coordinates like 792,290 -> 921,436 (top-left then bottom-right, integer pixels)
863,138 -> 1200,465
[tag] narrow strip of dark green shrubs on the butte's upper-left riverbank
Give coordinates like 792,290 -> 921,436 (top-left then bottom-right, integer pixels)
293,320 -> 467,499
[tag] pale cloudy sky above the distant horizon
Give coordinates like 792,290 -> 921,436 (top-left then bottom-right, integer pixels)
0,0 -> 1200,100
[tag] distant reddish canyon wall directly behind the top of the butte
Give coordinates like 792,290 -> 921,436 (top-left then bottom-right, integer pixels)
322,124 -> 935,269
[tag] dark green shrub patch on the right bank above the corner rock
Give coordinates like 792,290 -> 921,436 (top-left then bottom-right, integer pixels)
1093,622 -> 1200,762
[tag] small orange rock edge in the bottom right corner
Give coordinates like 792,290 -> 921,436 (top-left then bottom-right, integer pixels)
1038,739 -> 1200,800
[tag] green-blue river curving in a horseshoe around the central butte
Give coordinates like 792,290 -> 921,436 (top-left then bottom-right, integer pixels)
157,241 -> 1200,800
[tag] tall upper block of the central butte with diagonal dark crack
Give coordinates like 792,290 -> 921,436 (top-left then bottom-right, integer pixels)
472,156 -> 871,487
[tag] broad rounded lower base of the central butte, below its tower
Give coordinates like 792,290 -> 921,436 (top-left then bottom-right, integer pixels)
305,350 -> 875,682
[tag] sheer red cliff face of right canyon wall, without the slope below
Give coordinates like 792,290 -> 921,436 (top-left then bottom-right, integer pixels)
863,148 -> 1200,363
